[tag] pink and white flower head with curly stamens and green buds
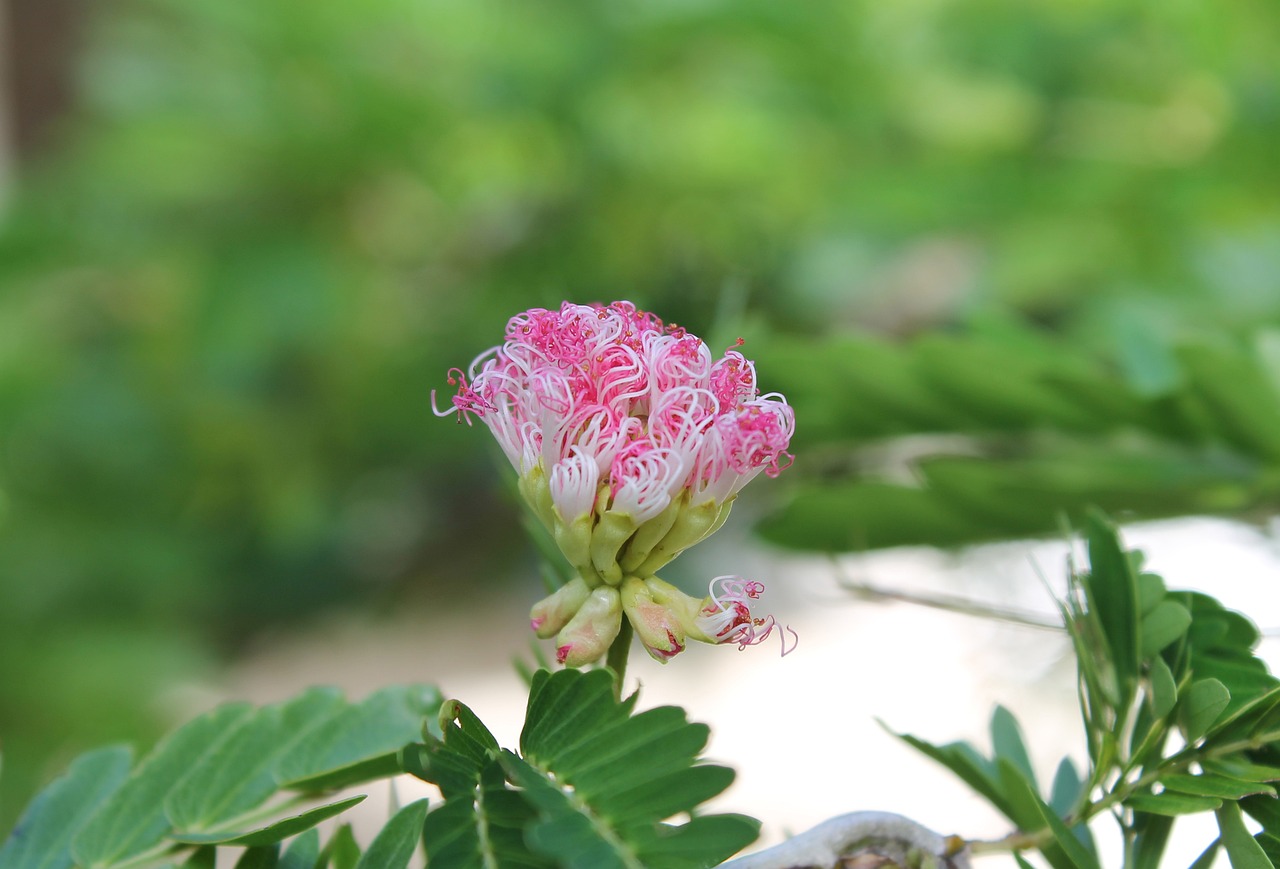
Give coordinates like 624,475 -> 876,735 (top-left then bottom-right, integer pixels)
436,302 -> 795,663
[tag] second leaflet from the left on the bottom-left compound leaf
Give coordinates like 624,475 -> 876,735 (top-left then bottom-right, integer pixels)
72,703 -> 251,869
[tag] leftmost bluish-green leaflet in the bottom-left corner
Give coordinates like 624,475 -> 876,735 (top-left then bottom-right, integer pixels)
0,746 -> 133,869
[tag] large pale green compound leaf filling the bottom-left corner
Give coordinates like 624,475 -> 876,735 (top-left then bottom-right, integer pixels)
0,686 -> 439,869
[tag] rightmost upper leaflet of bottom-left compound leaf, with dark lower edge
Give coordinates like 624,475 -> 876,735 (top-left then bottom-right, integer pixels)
275,685 -> 440,791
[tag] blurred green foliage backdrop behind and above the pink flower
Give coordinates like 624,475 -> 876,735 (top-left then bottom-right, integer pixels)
0,0 -> 1280,833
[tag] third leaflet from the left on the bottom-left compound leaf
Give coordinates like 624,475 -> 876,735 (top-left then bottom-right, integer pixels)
165,689 -> 346,833
